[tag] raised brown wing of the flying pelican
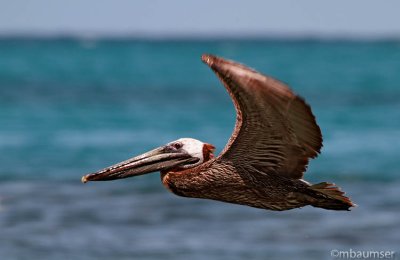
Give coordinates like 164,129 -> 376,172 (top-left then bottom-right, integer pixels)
202,55 -> 322,179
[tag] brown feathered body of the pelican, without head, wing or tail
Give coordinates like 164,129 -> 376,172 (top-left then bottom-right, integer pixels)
161,159 -> 311,210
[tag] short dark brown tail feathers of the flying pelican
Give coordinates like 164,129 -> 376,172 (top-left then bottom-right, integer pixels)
309,182 -> 356,210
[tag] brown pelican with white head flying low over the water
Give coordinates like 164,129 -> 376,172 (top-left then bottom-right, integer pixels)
82,55 -> 354,210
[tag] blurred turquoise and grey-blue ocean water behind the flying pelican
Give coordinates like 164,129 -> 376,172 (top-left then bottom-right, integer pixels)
0,39 -> 400,259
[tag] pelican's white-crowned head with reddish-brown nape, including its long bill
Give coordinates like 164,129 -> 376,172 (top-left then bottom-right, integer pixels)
82,138 -> 215,183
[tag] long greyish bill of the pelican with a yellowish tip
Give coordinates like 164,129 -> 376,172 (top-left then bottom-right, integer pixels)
82,146 -> 198,183
